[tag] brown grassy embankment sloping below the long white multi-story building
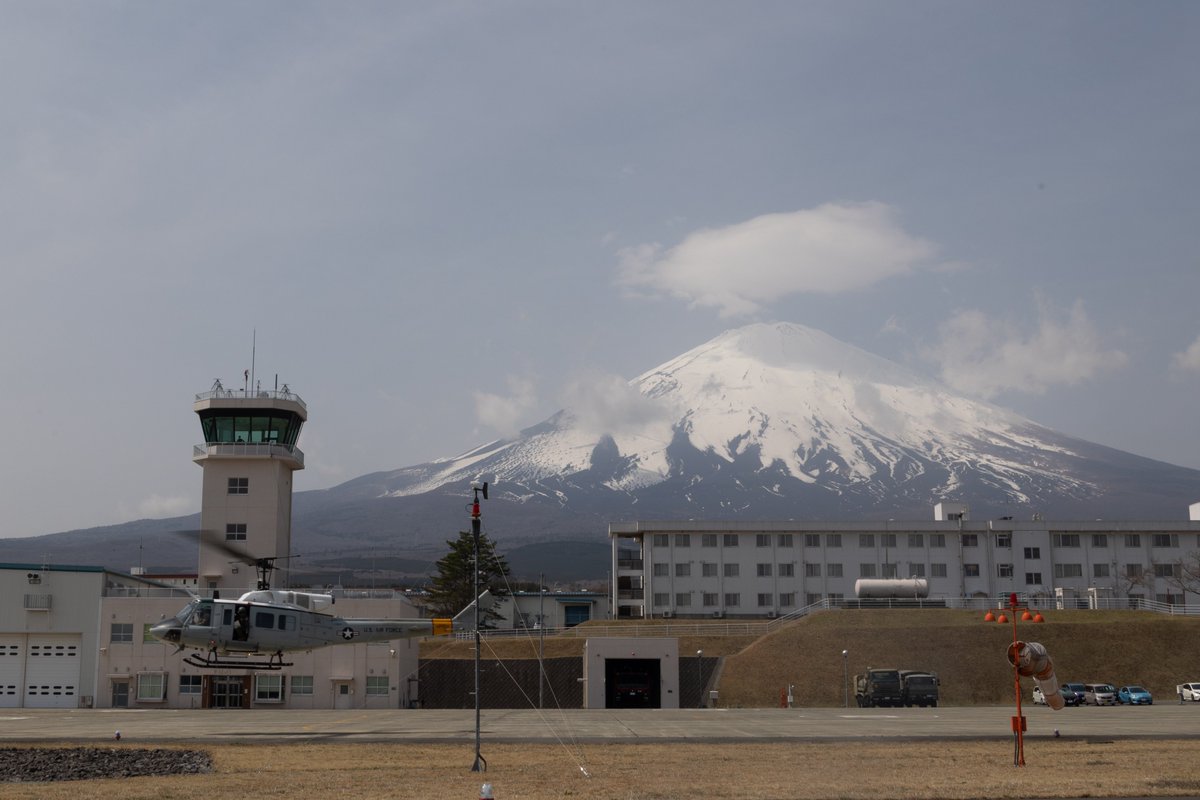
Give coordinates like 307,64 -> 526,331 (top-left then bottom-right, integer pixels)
421,609 -> 1200,708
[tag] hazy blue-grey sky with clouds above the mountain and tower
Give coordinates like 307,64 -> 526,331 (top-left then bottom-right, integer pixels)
0,0 -> 1200,536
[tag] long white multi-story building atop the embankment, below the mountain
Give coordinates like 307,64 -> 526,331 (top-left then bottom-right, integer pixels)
608,504 -> 1200,619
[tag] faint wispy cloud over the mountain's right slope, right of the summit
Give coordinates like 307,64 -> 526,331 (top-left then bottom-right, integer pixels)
926,301 -> 1128,397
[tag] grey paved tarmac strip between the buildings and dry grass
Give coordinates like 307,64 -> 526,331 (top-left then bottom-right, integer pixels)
0,704 -> 1200,742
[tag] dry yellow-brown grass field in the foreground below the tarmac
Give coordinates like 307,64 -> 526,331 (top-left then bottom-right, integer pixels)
0,739 -> 1200,800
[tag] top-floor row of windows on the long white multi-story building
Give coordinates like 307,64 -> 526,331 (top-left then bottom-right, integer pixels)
652,532 -> 1200,558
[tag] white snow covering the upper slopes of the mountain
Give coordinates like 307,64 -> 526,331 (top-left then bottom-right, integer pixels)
386,323 -> 1099,503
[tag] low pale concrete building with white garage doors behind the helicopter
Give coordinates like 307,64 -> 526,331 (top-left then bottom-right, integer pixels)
0,564 -> 441,709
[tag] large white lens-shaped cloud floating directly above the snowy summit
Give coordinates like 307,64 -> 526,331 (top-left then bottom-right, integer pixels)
618,203 -> 936,317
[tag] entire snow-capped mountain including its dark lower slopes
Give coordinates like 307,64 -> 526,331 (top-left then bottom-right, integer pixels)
0,323 -> 1200,579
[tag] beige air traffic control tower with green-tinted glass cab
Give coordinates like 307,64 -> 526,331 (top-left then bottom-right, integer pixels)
192,380 -> 308,590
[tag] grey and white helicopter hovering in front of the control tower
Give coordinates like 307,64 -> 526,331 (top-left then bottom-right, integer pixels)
150,537 -> 490,670
